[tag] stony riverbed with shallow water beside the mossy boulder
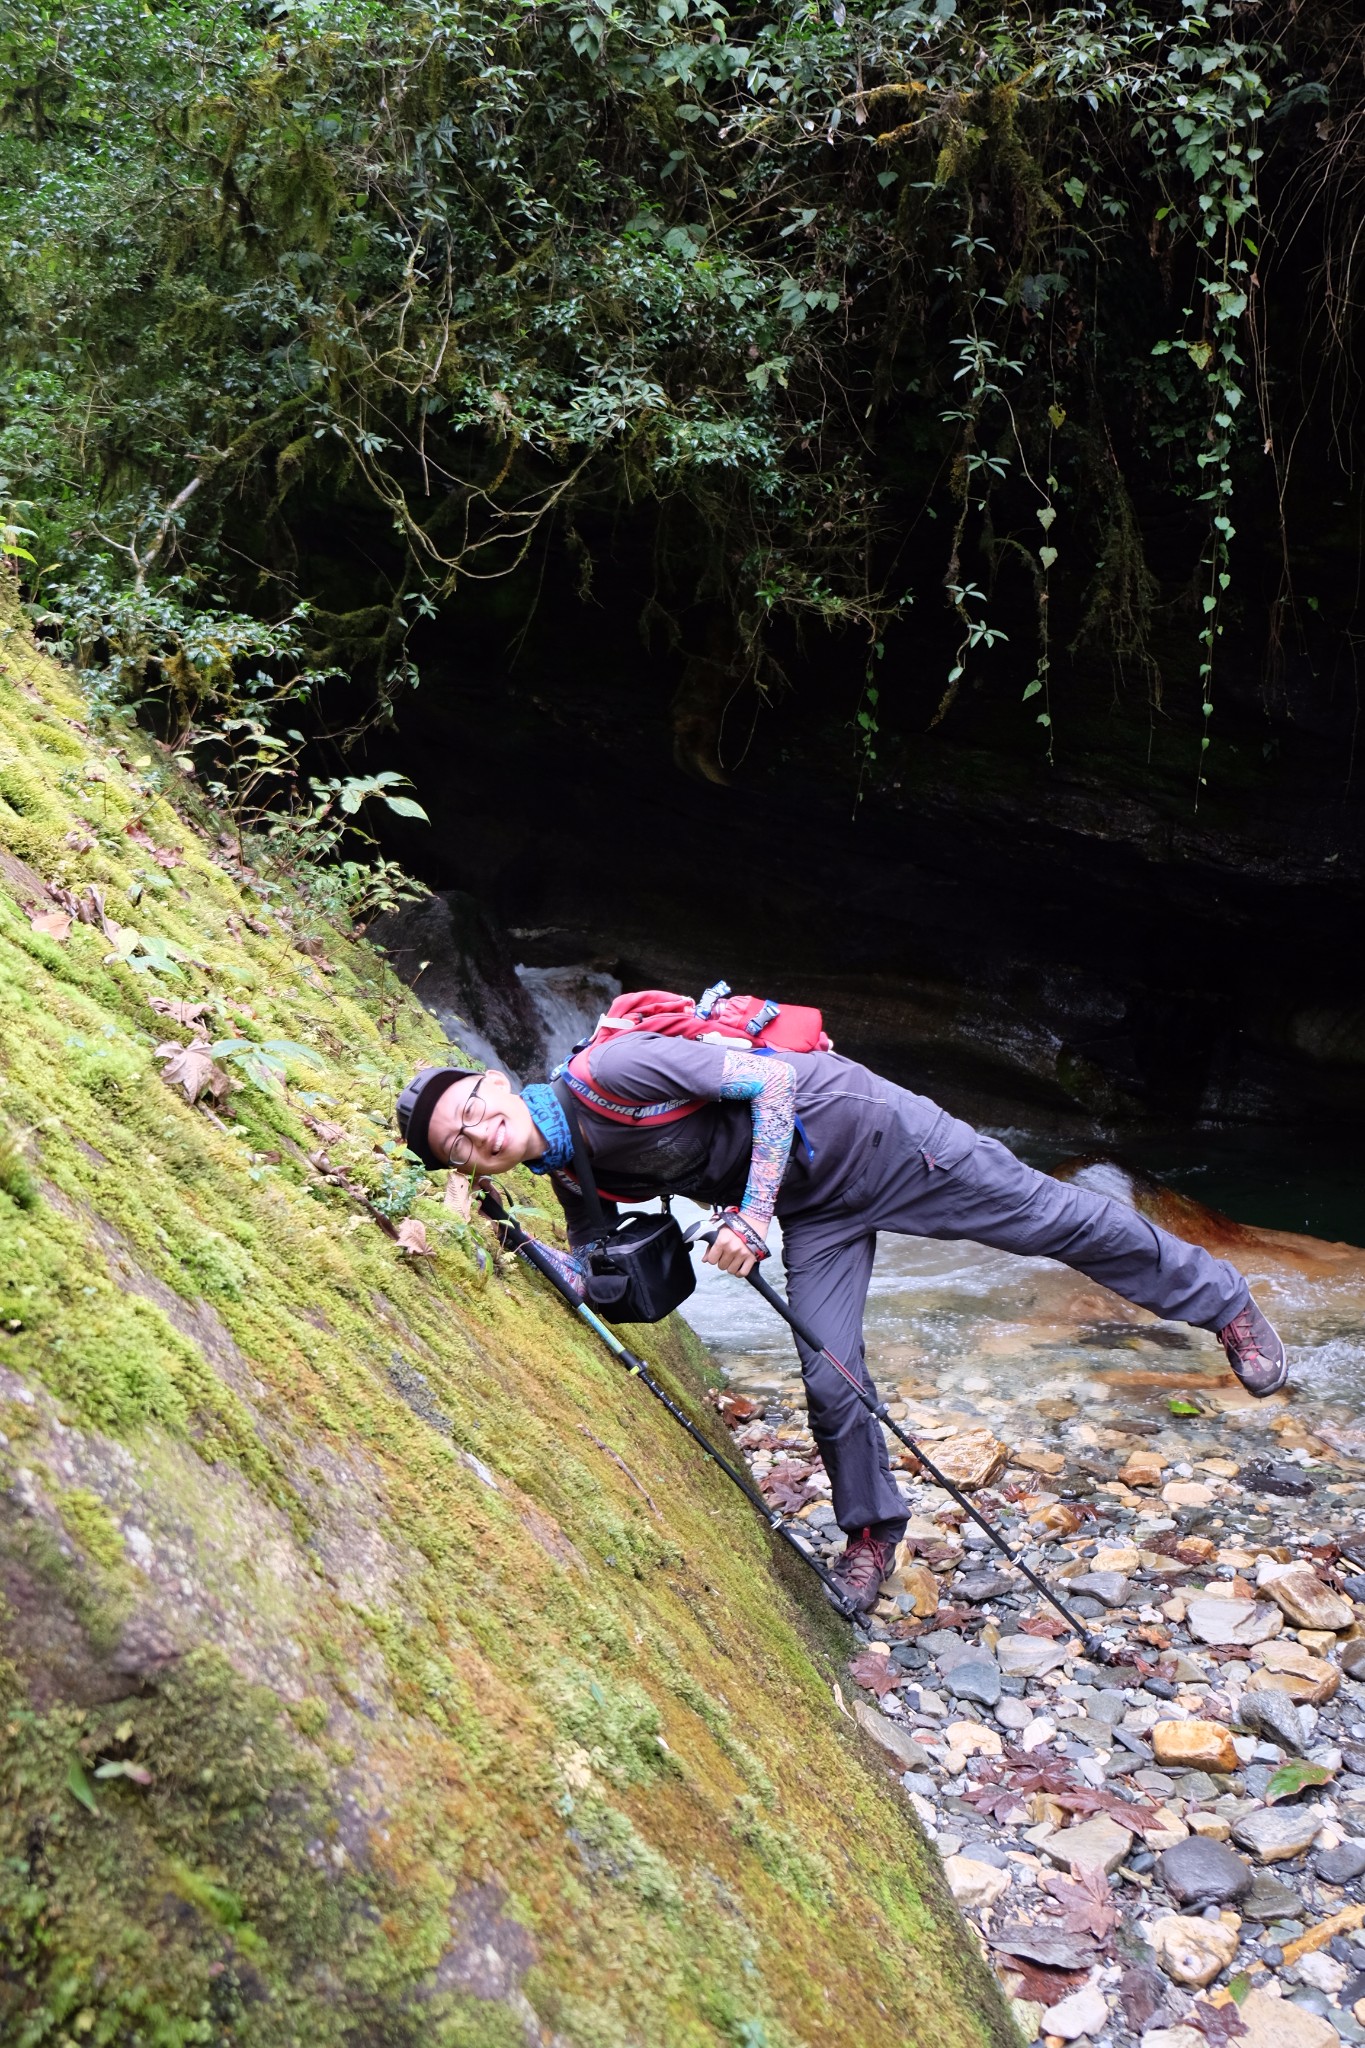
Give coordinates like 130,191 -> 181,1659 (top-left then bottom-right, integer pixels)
694,1167 -> 1365,2048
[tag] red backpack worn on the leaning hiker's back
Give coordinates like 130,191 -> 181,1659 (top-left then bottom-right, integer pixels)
561,981 -> 833,1124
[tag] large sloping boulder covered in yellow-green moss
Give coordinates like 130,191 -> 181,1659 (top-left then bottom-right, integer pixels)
0,610 -> 1011,2048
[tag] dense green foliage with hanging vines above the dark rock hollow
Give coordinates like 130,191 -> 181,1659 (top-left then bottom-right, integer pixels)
0,0 -> 1361,782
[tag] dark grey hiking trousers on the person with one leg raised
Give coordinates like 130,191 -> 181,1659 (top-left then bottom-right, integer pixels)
782,1090 -> 1250,1540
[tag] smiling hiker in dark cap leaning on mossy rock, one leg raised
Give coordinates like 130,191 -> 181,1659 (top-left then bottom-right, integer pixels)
399,1003 -> 1289,1612
